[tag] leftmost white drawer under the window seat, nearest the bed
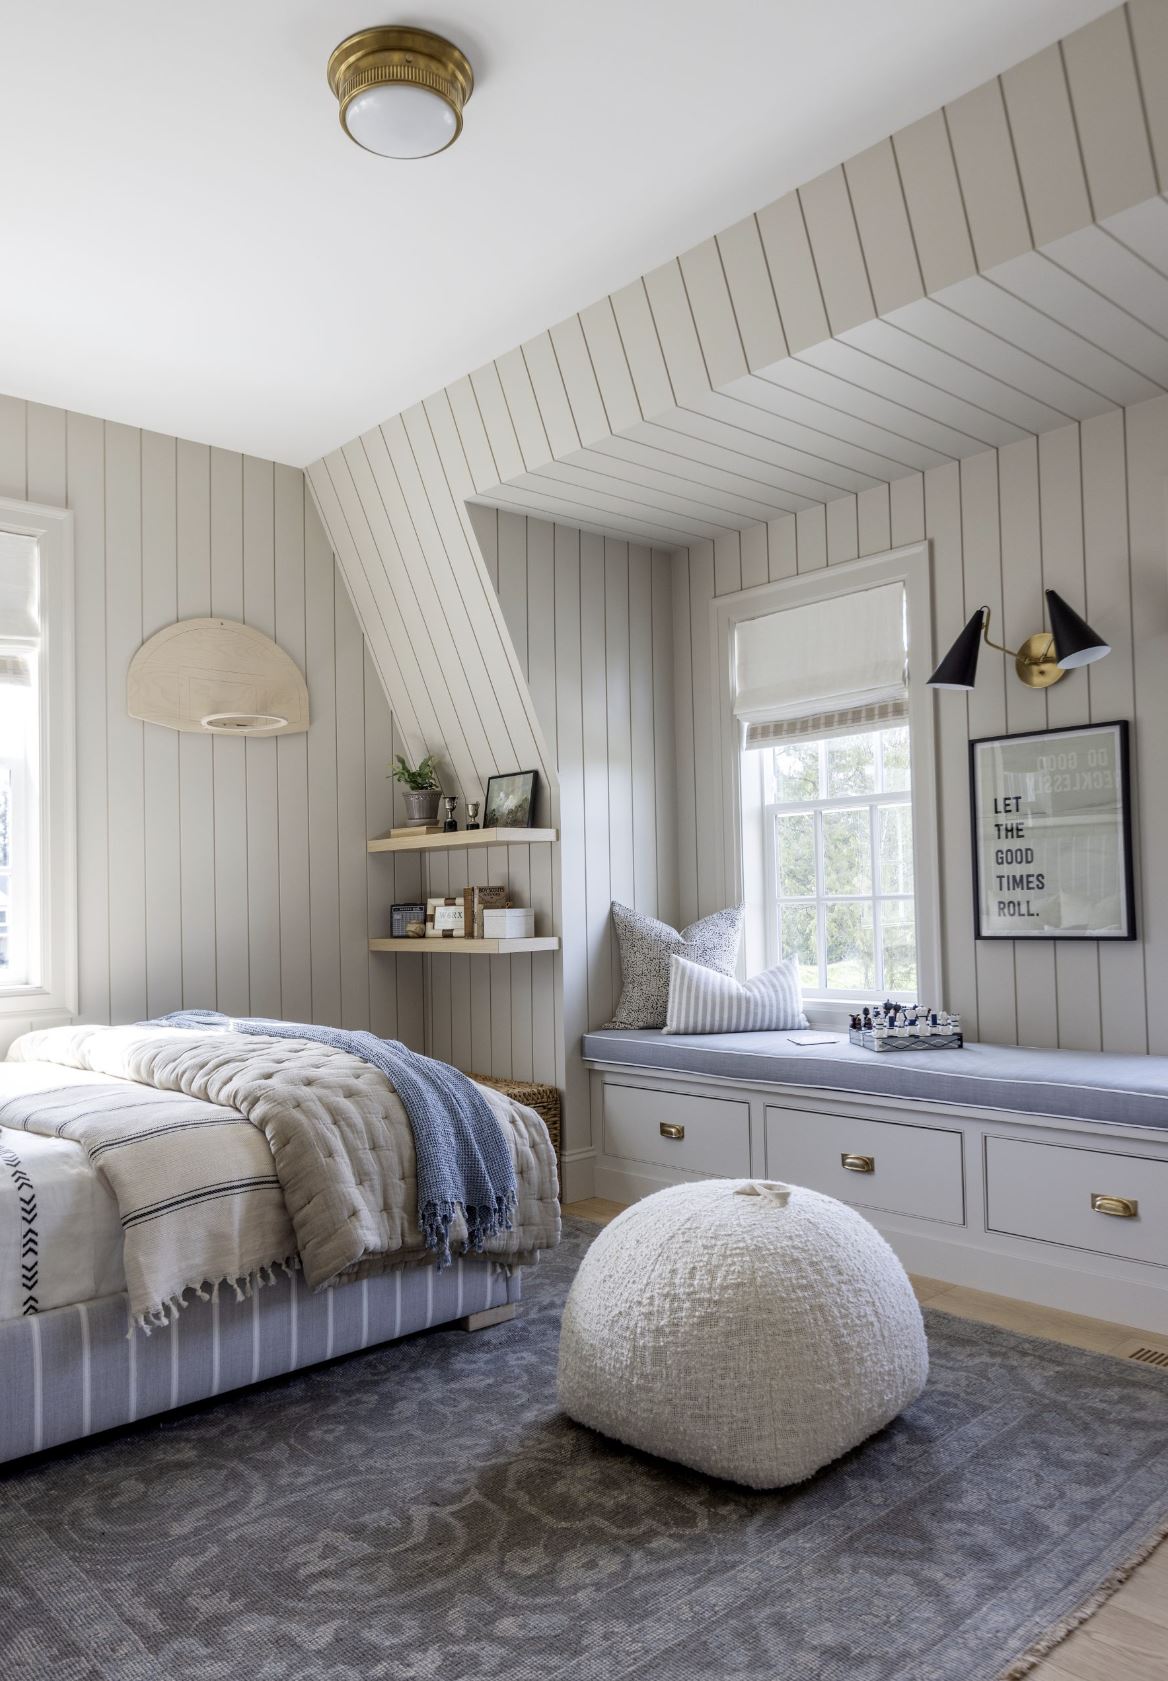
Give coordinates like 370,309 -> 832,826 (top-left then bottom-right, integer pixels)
605,1081 -> 750,1178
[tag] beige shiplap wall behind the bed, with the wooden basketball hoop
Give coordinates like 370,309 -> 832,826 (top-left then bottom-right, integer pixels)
0,397 -> 422,1044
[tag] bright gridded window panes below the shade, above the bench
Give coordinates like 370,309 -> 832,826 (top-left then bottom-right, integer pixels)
761,723 -> 918,999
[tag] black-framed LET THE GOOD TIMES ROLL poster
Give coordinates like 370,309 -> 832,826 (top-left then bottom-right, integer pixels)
970,723 -> 1136,940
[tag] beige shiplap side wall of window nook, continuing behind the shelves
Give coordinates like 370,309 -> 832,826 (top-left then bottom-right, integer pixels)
436,504 -> 677,1172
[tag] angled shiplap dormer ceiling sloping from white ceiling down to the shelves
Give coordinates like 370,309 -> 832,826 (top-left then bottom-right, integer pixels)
309,0 -> 1168,792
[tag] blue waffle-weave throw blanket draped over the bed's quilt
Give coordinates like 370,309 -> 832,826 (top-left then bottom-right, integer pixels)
146,1010 -> 516,1267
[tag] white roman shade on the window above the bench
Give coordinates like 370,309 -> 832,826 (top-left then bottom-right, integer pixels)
734,583 -> 908,748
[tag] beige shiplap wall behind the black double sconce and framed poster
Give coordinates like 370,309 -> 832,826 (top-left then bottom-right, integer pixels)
674,397 -> 1168,1054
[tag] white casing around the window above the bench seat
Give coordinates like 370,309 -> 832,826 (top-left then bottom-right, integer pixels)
699,540 -> 944,1027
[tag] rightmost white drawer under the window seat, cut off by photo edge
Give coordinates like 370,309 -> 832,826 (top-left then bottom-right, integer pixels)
985,1136 -> 1168,1266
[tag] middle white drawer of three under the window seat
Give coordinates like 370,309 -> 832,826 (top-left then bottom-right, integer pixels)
766,1108 -> 965,1225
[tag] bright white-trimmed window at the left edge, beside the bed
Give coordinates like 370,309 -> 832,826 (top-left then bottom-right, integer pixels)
0,499 -> 77,1024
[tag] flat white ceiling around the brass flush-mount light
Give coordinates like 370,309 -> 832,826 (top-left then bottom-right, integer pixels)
0,0 -> 1114,464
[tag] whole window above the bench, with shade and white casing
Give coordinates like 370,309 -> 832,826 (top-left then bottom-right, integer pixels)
714,543 -> 944,1029
